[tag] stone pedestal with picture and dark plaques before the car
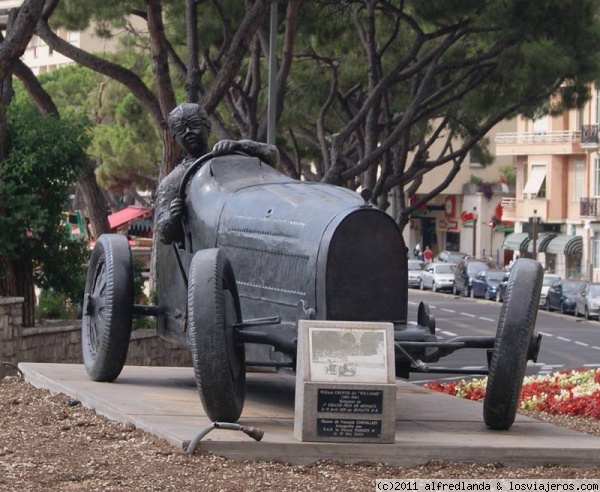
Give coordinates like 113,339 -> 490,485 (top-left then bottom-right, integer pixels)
294,320 -> 396,443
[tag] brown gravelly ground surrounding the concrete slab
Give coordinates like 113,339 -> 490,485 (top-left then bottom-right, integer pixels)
0,377 -> 600,492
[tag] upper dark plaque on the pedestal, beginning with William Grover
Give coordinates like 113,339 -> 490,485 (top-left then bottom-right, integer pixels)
317,388 -> 383,414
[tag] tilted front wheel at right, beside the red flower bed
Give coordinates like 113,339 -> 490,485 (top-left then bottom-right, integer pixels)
483,258 -> 544,430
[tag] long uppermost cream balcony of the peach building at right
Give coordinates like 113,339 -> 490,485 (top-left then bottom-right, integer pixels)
495,130 -> 584,155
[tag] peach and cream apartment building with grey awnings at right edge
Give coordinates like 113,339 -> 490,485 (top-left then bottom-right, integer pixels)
496,89 -> 600,281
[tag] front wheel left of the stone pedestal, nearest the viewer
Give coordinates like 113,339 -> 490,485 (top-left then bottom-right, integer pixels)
188,249 -> 246,422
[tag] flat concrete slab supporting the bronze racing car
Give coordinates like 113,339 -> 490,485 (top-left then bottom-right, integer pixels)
19,363 -> 600,466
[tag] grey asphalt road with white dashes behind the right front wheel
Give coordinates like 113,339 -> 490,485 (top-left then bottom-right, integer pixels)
408,289 -> 600,382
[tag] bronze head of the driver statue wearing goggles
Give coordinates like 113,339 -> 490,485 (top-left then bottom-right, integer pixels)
167,103 -> 210,157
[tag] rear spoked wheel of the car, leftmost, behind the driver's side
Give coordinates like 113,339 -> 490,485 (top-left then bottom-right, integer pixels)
81,234 -> 134,382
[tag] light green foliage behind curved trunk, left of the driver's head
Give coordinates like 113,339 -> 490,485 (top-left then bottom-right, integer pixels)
34,57 -> 161,193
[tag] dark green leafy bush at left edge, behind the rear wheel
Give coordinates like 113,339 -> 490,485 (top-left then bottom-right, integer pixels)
0,102 -> 89,299
